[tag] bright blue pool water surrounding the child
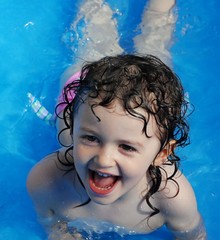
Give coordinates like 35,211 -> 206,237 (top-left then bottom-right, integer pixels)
0,0 -> 220,240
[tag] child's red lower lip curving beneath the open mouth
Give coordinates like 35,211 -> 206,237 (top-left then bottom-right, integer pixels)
89,171 -> 120,195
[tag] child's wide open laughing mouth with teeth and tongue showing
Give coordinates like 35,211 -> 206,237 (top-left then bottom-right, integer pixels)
89,170 -> 120,195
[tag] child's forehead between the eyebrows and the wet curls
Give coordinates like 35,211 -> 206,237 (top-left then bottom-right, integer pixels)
74,98 -> 158,138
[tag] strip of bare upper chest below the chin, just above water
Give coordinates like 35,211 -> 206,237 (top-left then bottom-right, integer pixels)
55,194 -> 164,233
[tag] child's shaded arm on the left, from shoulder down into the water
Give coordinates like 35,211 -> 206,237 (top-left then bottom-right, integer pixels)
27,150 -> 83,240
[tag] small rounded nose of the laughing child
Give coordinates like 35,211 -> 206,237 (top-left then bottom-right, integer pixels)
95,147 -> 116,168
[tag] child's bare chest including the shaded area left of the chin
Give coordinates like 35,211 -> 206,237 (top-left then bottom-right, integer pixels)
51,172 -> 164,233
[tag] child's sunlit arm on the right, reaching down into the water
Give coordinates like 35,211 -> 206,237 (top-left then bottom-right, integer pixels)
159,167 -> 207,240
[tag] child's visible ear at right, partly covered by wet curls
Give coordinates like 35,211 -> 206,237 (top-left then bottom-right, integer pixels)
154,140 -> 176,166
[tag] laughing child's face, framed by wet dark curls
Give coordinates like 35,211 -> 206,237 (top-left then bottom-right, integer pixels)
73,97 -> 161,204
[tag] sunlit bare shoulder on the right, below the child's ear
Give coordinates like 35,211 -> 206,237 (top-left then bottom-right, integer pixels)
157,166 -> 200,231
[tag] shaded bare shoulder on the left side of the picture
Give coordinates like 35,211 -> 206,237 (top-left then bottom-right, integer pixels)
27,150 -> 75,219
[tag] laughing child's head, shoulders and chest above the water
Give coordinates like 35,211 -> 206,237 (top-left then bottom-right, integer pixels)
28,55 -> 206,240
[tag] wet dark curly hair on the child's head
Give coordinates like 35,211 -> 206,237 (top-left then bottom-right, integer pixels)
56,55 -> 189,221
